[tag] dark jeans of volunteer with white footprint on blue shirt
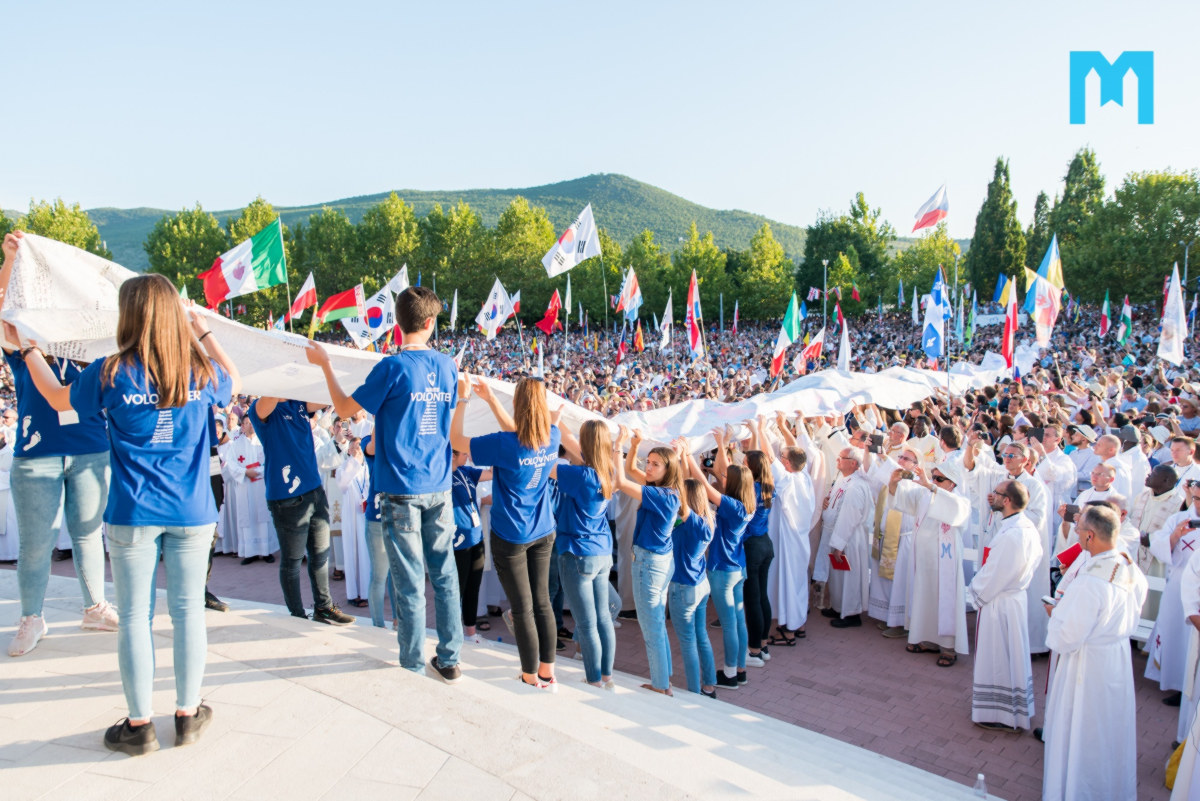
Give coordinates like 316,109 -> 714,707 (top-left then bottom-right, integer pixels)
266,487 -> 334,618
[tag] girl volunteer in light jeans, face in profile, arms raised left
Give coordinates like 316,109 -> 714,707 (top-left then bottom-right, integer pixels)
613,426 -> 689,695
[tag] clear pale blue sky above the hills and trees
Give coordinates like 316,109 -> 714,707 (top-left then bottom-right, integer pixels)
0,1 -> 1200,236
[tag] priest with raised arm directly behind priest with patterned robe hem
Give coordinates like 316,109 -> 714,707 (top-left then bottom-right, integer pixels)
962,441 -> 1054,654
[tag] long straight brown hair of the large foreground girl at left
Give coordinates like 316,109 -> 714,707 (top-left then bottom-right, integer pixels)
101,273 -> 217,409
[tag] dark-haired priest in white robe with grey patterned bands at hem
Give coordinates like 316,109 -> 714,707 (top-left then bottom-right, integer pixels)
967,480 -> 1045,731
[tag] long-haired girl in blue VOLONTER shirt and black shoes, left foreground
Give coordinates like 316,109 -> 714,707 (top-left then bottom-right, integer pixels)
22,275 -> 240,755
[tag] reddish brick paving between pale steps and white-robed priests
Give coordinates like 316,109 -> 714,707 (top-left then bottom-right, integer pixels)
16,556 -> 1177,801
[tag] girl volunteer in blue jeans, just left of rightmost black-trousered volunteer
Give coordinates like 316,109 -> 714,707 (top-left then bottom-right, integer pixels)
704,428 -> 757,689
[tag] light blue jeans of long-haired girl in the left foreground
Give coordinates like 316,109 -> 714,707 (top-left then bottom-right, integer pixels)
108,524 -> 216,719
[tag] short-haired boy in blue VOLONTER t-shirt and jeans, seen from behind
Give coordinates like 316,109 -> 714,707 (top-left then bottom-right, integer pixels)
307,287 -> 463,682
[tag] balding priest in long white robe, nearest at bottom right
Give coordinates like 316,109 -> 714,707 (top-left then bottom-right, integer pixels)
1042,507 -> 1146,801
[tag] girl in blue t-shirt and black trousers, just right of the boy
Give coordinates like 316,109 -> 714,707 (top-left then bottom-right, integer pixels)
450,375 -> 560,691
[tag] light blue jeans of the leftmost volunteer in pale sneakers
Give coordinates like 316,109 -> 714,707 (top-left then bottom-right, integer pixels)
11,451 -> 108,615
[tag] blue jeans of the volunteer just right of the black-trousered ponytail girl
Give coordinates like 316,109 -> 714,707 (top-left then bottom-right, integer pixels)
558,553 -> 617,683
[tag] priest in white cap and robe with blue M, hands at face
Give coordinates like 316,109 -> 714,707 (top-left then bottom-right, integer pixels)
888,462 -> 971,668
